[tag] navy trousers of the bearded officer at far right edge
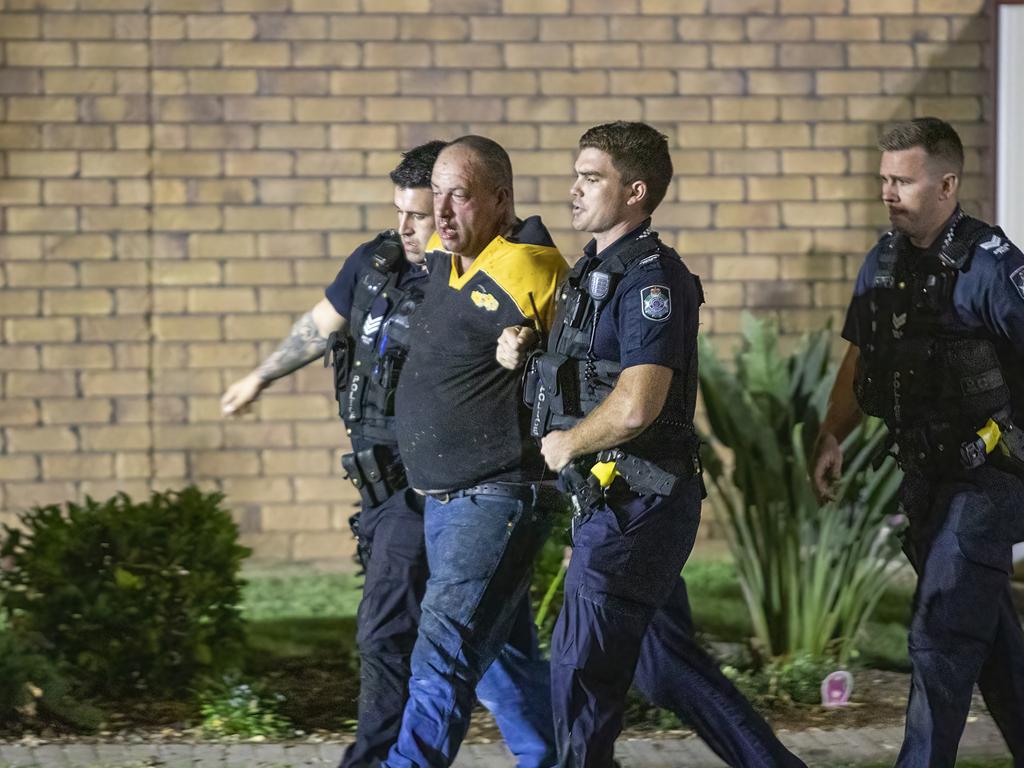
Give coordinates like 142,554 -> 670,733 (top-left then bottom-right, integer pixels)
896,466 -> 1024,768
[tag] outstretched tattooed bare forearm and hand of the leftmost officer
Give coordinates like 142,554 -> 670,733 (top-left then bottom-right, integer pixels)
220,299 -> 347,416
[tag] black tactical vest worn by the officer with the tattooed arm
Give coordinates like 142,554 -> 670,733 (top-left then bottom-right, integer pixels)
329,237 -> 423,444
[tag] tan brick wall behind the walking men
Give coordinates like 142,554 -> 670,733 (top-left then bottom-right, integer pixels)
0,0 -> 990,559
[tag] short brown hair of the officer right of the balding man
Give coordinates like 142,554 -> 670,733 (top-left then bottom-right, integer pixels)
580,120 -> 672,213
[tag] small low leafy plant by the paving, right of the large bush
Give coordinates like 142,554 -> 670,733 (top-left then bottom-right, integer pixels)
200,676 -> 294,738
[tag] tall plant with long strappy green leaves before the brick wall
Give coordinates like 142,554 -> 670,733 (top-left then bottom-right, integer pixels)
700,314 -> 899,660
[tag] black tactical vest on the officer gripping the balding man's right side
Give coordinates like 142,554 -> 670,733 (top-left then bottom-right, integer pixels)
524,229 -> 703,464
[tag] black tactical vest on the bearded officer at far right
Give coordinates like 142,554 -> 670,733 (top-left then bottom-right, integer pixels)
854,212 -> 1011,467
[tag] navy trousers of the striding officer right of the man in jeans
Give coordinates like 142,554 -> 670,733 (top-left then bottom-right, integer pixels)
551,479 -> 804,768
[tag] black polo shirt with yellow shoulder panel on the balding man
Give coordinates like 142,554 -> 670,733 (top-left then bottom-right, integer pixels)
395,216 -> 566,490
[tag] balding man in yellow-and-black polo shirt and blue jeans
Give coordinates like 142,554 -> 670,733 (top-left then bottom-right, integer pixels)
384,136 -> 566,768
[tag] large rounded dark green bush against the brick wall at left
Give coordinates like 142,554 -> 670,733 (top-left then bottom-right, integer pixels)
0,487 -> 248,698
